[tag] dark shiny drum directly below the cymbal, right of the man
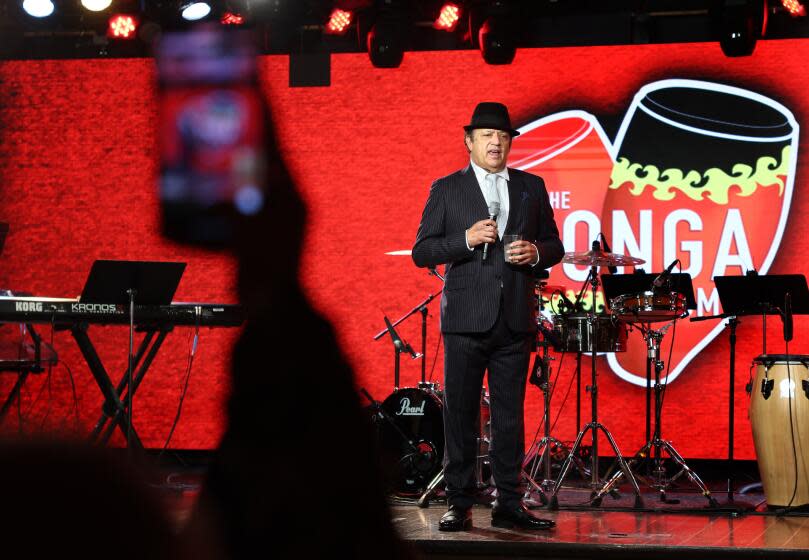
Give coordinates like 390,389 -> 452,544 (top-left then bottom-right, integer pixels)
553,313 -> 627,352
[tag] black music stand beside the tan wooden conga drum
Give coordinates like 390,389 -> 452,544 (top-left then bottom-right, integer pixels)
712,273 -> 809,502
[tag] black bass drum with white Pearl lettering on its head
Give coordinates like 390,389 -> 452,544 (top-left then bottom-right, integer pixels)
378,388 -> 444,495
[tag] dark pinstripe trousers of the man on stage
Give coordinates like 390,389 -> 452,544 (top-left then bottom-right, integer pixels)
444,298 -> 533,508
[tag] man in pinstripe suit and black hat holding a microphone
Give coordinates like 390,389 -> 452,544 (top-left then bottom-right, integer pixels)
413,102 -> 564,531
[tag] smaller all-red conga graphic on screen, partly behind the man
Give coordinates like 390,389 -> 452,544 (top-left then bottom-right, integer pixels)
509,111 -> 613,308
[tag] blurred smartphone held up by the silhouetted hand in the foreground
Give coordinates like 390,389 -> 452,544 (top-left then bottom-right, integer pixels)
155,26 -> 267,247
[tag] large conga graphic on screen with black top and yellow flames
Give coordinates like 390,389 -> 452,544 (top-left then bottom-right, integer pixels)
602,80 -> 798,385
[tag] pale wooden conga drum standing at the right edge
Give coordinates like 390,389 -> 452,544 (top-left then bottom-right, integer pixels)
749,354 -> 809,507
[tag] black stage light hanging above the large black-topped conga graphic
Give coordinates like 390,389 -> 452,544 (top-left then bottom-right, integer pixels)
718,0 -> 767,57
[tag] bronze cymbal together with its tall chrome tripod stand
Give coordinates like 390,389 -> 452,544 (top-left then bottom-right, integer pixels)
548,247 -> 643,509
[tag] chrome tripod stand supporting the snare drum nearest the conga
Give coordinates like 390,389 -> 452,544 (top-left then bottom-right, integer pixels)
596,323 -> 718,507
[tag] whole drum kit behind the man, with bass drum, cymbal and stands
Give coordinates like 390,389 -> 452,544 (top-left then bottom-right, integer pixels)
366,242 -> 715,509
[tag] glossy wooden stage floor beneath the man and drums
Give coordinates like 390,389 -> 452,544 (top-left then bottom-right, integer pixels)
391,495 -> 809,560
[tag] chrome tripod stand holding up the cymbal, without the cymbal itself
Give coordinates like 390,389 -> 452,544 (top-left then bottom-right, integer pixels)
548,260 -> 643,509
